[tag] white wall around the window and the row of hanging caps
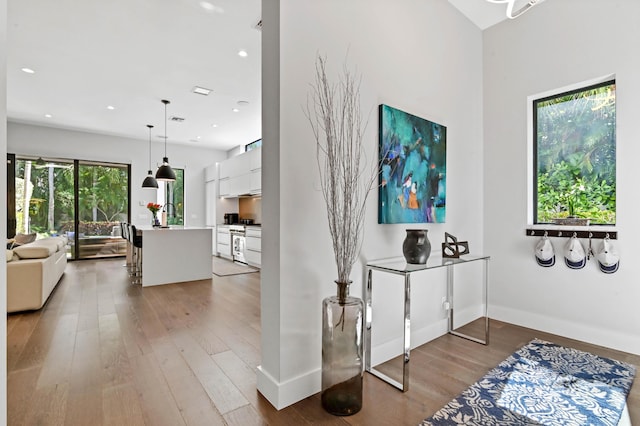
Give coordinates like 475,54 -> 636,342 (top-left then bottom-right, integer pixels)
483,0 -> 640,354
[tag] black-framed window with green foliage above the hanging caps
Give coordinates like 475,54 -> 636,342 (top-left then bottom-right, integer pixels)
533,80 -> 616,225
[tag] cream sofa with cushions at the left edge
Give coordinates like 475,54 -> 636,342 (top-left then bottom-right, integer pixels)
7,237 -> 67,312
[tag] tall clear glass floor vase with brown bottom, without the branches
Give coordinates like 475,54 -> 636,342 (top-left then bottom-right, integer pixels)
322,282 -> 364,416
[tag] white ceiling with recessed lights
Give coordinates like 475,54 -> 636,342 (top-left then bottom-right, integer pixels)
7,0 -> 536,150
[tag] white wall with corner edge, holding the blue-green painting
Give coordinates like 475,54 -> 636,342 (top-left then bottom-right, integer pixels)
258,0 -> 483,408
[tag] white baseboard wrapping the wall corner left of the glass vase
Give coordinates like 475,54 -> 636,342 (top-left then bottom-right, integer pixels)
257,365 -> 322,410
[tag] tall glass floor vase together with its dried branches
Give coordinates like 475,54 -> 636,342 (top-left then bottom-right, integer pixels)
305,57 -> 379,416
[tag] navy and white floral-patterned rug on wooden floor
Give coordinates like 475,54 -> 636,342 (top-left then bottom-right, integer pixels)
420,339 -> 636,426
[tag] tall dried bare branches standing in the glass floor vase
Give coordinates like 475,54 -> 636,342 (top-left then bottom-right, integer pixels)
305,56 -> 379,283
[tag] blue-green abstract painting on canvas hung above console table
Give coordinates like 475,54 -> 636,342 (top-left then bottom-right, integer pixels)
378,105 -> 447,224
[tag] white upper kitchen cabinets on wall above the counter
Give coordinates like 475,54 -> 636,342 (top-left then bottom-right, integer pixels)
219,148 -> 262,197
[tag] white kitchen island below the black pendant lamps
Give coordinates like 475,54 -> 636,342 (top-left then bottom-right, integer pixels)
139,225 -> 212,287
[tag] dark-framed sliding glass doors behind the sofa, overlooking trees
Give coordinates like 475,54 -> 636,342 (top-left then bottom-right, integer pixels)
8,155 -> 130,259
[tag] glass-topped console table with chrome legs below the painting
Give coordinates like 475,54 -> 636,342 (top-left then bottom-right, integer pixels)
364,255 -> 490,392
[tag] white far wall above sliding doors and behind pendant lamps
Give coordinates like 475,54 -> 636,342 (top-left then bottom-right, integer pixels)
7,122 -> 226,226
